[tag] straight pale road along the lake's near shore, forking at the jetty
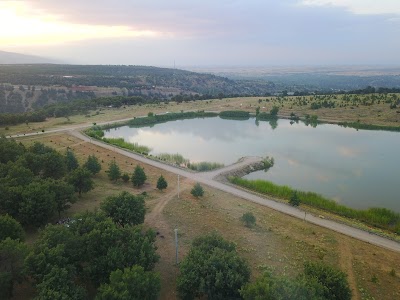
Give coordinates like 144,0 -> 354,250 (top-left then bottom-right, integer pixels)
69,130 -> 400,252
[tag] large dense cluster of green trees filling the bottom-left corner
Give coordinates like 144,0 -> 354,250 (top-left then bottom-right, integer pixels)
0,203 -> 160,300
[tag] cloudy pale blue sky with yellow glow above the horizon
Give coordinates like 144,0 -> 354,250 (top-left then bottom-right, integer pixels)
0,0 -> 400,66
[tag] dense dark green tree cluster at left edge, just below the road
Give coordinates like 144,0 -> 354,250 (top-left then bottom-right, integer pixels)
0,137 -> 101,227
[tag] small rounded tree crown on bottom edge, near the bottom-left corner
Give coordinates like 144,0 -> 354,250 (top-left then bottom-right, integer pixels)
35,267 -> 87,300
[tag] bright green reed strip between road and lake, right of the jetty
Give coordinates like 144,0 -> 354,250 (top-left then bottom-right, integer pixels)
229,177 -> 400,234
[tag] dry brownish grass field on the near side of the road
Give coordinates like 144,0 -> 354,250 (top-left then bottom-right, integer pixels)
16,134 -> 400,299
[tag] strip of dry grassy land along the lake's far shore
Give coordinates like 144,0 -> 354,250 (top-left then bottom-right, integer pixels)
0,94 -> 400,135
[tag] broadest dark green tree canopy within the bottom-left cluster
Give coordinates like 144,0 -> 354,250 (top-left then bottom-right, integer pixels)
26,212 -> 158,299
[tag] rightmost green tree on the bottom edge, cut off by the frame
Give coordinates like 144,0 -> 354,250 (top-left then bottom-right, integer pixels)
304,262 -> 351,300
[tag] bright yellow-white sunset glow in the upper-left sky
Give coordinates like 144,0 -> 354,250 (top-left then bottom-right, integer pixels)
0,1 -> 158,47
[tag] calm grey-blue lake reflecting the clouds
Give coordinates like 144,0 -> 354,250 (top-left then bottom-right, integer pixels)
105,117 -> 400,212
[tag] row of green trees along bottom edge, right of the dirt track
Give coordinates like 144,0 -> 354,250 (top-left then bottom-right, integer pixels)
177,233 -> 351,300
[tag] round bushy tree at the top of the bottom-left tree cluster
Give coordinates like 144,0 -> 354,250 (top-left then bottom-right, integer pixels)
101,192 -> 146,226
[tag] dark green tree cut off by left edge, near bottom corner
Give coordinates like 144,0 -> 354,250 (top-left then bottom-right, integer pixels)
0,238 -> 29,299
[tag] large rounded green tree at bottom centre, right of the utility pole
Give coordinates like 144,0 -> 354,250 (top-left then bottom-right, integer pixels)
177,233 -> 250,299
